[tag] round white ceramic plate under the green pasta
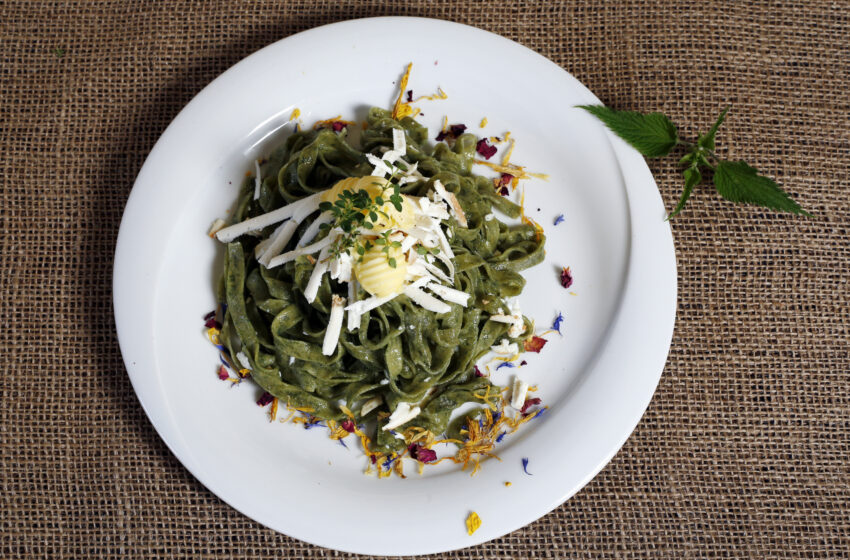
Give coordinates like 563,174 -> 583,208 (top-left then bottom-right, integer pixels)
114,18 -> 676,555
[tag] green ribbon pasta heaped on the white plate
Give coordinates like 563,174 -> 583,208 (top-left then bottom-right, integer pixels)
220,109 -> 544,451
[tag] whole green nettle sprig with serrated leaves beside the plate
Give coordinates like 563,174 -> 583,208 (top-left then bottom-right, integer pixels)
579,105 -> 811,219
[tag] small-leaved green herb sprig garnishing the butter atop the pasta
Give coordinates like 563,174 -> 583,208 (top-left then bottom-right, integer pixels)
319,172 -> 403,268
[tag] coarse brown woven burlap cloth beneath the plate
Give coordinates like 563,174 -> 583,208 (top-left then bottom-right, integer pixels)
0,0 -> 850,559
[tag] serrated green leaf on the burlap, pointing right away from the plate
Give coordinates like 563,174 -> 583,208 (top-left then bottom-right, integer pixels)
714,161 -> 811,216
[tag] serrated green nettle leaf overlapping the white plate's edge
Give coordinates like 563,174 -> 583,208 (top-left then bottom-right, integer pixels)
579,105 -> 679,157
